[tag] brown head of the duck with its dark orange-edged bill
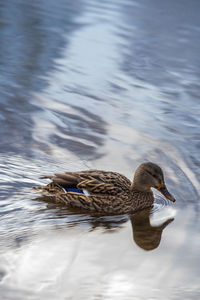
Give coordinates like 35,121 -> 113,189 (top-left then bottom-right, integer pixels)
133,162 -> 176,202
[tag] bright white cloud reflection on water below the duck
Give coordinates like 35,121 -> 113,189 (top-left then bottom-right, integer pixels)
1,206 -> 200,299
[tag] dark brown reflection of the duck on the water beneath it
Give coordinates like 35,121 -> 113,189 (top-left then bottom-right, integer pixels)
37,197 -> 174,251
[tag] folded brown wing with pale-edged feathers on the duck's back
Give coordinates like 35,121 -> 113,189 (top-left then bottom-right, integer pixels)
43,170 -> 131,195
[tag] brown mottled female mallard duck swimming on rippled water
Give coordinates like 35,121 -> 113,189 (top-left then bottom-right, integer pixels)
36,162 -> 175,214
